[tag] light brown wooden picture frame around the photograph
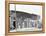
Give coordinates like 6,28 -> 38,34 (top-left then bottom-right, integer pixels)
5,1 -> 45,36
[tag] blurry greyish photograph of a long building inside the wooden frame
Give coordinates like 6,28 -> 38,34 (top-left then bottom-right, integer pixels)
9,4 -> 42,32
